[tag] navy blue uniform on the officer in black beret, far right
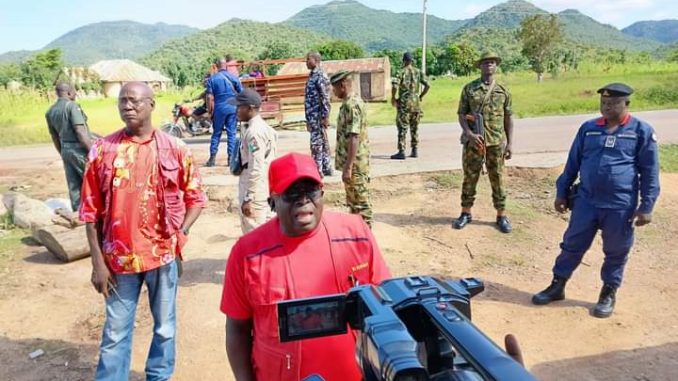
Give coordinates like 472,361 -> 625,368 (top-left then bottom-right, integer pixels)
553,114 -> 659,288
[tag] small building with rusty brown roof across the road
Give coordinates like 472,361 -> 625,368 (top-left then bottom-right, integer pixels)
278,57 -> 391,102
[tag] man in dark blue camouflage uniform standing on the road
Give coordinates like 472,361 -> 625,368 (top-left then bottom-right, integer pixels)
304,52 -> 332,176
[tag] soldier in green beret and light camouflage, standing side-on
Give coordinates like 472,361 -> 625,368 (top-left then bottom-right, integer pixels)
330,70 -> 372,226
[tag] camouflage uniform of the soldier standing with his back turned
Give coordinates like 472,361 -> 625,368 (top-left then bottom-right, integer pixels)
392,65 -> 428,152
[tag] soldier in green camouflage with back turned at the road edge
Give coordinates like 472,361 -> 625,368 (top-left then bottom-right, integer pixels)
391,52 -> 429,160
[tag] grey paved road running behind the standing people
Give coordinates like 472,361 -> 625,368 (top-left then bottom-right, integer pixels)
0,110 -> 678,183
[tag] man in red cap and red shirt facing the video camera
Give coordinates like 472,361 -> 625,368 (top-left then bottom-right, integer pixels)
221,153 -> 390,381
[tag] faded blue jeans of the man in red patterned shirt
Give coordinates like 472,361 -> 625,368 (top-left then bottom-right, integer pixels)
95,261 -> 178,381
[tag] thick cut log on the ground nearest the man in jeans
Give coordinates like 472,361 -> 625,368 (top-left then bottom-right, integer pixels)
34,225 -> 89,262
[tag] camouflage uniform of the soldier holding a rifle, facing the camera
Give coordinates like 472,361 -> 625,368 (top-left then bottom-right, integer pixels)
458,78 -> 512,210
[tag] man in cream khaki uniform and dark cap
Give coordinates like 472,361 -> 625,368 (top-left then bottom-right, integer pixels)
229,89 -> 278,234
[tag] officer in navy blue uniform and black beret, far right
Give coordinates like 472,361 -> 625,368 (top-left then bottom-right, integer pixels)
532,83 -> 659,318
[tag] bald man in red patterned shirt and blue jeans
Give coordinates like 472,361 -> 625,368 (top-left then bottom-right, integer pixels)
80,82 -> 205,380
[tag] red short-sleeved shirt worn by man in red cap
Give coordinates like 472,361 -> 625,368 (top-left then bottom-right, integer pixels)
221,212 -> 390,381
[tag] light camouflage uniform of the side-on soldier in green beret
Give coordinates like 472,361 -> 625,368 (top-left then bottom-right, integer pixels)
335,95 -> 372,226
